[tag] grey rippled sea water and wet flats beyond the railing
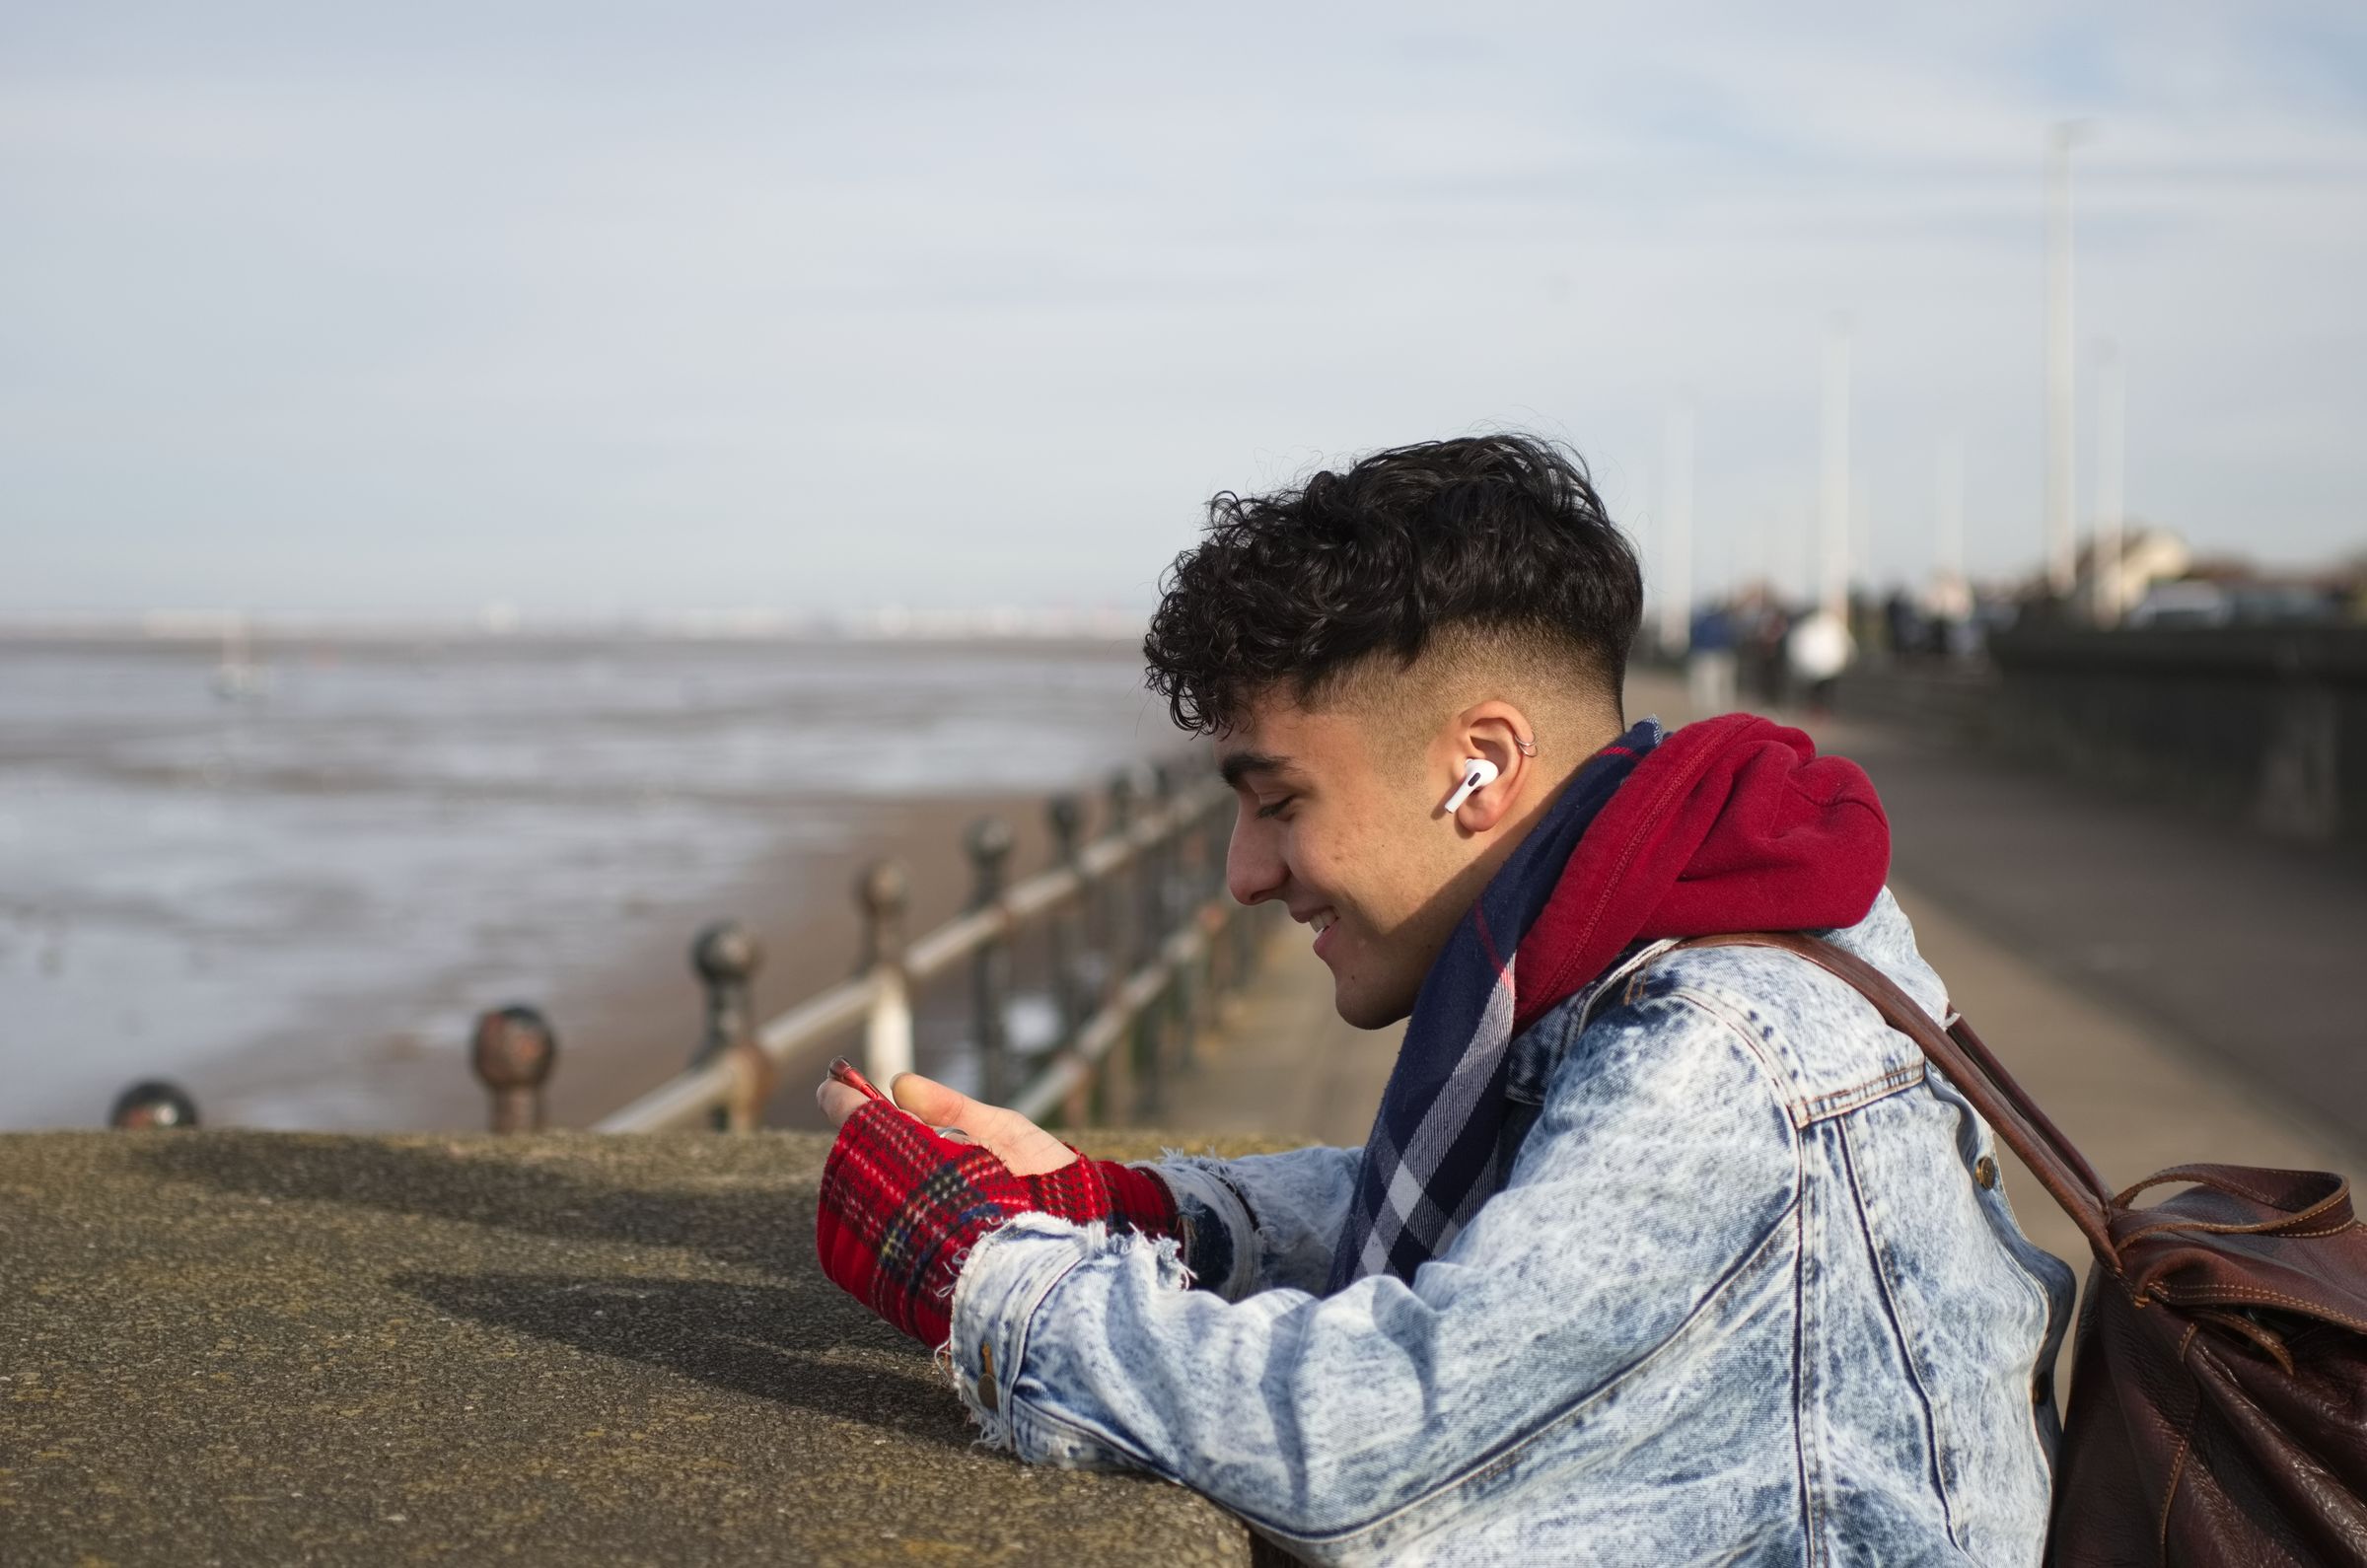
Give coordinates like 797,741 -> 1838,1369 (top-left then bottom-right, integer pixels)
0,637 -> 1177,1127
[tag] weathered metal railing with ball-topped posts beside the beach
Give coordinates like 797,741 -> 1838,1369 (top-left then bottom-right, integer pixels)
457,767 -> 1273,1132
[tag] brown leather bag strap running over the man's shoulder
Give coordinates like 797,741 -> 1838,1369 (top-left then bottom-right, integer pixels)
1679,931 -> 2120,1274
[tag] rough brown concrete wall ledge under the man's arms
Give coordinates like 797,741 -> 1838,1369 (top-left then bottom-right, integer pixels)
0,1130 -> 1278,1568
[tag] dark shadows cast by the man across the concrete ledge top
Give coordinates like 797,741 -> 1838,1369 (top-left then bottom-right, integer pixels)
122,1132 -> 975,1448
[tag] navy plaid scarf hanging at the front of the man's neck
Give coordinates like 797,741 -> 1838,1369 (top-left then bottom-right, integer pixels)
1330,718 -> 1662,1291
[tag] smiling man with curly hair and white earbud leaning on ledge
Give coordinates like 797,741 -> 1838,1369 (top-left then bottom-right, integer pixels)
817,436 -> 2071,1566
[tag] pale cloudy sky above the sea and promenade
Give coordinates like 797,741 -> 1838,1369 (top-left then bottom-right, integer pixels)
0,0 -> 2367,615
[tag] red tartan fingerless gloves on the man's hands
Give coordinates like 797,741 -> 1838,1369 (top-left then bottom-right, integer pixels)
815,1102 -> 1177,1345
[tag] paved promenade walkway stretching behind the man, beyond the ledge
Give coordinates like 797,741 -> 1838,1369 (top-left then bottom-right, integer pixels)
1165,673 -> 2367,1383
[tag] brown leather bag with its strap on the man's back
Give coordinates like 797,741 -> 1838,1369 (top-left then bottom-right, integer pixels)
1681,933 -> 2367,1568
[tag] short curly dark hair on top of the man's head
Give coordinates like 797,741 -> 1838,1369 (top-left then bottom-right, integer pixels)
1143,436 -> 1643,735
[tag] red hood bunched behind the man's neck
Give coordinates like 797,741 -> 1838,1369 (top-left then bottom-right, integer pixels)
1513,713 -> 1892,1035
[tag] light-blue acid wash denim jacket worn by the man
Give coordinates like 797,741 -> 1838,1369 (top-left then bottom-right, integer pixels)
952,892 -> 2073,1568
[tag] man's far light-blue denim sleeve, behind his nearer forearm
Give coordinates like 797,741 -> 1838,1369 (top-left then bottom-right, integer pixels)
1150,1146 -> 1363,1301
